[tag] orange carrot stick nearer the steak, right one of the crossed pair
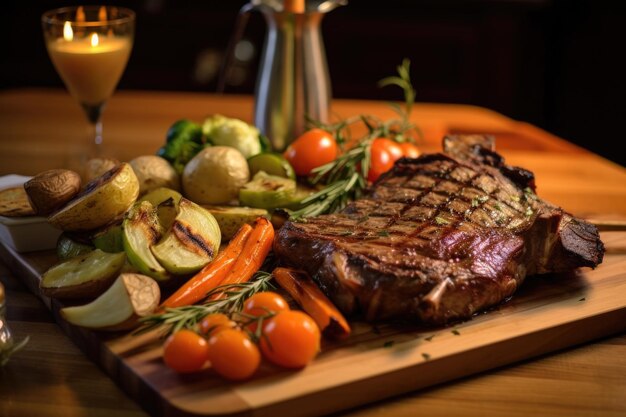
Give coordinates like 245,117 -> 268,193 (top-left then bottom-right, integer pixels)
211,217 -> 274,300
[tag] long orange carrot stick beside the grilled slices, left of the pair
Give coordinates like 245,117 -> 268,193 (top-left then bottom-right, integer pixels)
161,224 -> 252,308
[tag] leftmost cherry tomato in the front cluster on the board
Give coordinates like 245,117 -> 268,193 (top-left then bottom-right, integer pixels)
163,329 -> 209,373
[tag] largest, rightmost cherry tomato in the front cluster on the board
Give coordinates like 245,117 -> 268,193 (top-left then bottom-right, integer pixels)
259,310 -> 320,368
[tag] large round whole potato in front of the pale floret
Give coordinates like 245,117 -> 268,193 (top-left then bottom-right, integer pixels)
183,146 -> 250,204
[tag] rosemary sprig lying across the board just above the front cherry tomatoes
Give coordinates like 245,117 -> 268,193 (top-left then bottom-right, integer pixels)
135,271 -> 273,335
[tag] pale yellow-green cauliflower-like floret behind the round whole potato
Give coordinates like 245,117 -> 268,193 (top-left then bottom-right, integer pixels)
202,114 -> 262,158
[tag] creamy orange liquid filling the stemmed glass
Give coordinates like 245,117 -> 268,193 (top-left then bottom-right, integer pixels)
48,37 -> 132,106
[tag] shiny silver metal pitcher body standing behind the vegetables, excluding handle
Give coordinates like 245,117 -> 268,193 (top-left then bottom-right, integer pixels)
242,0 -> 346,151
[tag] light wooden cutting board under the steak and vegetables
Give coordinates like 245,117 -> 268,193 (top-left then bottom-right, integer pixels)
0,232 -> 626,416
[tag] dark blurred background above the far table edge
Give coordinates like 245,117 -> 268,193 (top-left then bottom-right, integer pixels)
0,0 -> 626,165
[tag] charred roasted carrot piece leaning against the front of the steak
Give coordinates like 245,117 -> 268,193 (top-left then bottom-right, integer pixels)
272,268 -> 350,339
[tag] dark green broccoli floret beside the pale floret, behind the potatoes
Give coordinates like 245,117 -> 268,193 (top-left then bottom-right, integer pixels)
157,119 -> 208,174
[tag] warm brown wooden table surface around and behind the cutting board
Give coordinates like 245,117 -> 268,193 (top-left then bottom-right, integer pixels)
0,90 -> 626,417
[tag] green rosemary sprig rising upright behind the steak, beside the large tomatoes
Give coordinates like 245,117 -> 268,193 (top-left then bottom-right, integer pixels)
287,59 -> 422,220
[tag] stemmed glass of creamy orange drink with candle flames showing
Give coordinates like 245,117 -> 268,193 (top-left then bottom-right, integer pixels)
41,6 -> 135,156
